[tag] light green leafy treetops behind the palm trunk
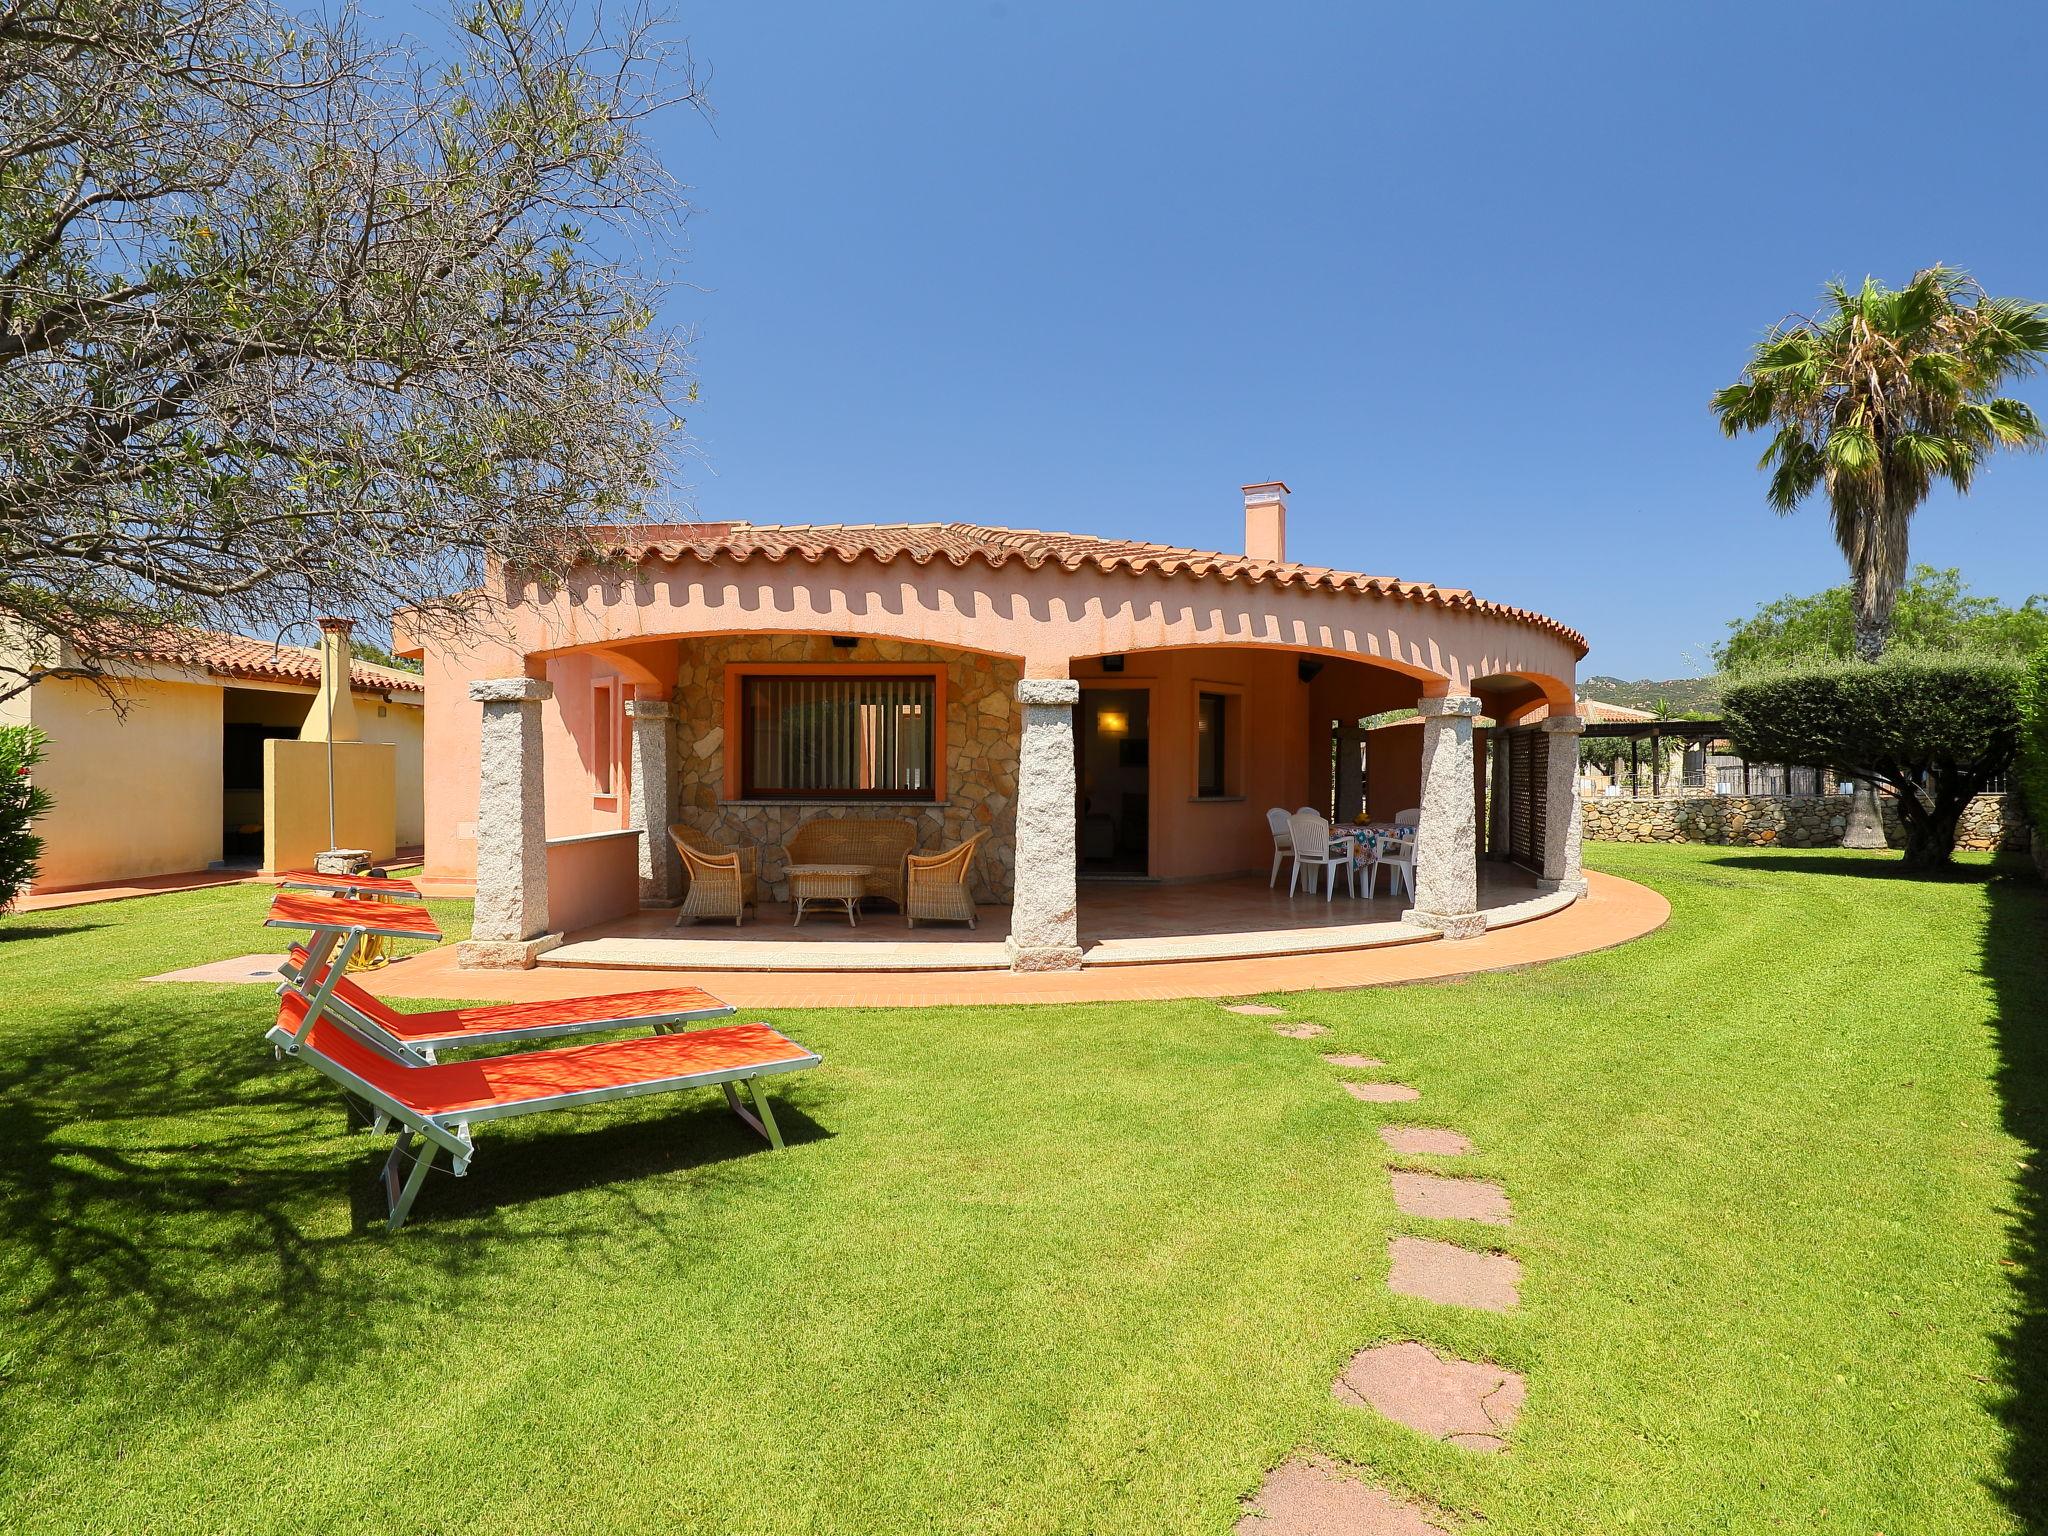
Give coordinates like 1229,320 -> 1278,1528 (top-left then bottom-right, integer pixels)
1714,565 -> 2048,672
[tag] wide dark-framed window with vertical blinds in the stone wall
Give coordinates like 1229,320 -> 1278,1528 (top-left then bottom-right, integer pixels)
737,670 -> 940,801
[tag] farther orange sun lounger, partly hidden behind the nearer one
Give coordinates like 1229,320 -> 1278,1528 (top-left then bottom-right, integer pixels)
283,944 -> 737,1067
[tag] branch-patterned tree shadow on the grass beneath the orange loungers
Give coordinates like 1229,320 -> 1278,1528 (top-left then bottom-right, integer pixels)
0,987 -> 827,1411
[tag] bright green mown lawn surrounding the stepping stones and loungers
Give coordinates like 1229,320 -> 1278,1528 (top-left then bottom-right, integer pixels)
0,846 -> 2048,1536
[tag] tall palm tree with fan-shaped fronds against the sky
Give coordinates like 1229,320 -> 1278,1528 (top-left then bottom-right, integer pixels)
1714,266 -> 2048,662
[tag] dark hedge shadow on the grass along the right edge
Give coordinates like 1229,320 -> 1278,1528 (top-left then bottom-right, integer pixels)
1982,860 -> 2048,1536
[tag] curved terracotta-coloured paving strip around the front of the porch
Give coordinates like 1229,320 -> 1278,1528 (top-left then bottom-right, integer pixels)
365,870 -> 1671,1008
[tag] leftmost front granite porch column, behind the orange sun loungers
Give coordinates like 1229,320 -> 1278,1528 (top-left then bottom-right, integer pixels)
457,678 -> 561,971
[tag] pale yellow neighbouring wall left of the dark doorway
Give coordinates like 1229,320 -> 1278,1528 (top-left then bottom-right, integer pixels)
27,680 -> 221,891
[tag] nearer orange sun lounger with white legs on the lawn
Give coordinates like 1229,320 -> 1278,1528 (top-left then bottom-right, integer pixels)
270,989 -> 819,1233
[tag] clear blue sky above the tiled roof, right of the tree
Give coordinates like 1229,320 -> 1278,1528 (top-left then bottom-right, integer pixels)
626,0 -> 2048,678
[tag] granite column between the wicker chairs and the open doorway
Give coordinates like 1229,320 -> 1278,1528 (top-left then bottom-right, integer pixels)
1008,678 -> 1081,971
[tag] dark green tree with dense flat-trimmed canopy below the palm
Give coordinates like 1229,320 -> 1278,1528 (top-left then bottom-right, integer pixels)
1720,651 -> 2025,868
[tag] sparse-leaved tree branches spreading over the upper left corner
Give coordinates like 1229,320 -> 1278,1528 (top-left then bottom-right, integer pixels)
0,0 -> 694,698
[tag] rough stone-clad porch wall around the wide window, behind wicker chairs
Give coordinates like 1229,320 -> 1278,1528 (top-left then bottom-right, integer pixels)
674,635 -> 1020,901
